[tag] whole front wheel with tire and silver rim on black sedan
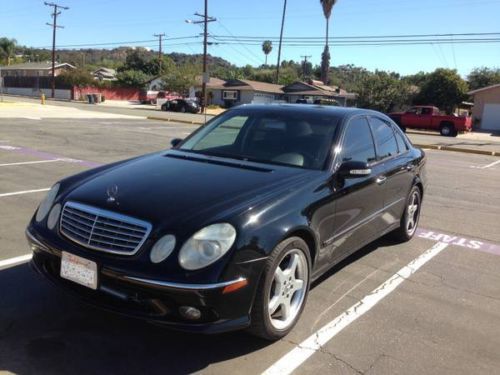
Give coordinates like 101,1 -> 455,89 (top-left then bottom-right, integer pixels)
249,237 -> 311,341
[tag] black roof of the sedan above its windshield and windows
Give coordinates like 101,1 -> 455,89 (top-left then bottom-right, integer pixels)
231,103 -> 384,118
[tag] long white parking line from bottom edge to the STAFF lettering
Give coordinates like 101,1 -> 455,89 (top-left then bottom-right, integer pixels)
263,242 -> 448,375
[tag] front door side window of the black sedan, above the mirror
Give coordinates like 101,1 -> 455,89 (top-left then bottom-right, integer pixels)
342,117 -> 377,163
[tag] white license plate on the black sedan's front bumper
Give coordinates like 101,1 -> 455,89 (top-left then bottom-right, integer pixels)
61,251 -> 97,290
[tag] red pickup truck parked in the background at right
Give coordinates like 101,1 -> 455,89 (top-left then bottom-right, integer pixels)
389,106 -> 472,137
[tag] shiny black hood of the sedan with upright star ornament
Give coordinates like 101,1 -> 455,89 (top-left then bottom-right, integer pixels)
65,150 -> 318,234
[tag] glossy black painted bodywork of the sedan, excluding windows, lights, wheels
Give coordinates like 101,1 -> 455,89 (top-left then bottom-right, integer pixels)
28,105 -> 425,332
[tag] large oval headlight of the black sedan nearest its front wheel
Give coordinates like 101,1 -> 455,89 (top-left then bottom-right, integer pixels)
179,223 -> 236,271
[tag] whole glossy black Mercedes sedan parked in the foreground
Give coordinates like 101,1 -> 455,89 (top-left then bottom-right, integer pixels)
26,105 -> 426,340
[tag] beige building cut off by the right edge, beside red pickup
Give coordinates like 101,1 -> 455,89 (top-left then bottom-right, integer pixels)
469,84 -> 500,131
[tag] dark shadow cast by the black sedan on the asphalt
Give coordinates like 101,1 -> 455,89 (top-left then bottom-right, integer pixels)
0,238 -> 395,375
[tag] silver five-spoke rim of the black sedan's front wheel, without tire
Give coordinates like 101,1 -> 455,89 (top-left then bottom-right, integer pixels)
268,249 -> 309,330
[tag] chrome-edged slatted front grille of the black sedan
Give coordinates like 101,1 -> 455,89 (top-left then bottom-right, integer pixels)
60,202 -> 151,255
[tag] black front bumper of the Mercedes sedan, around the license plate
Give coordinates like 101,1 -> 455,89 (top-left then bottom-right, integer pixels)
26,229 -> 260,333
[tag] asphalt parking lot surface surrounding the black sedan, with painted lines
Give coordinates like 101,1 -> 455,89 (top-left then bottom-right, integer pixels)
0,115 -> 500,374
